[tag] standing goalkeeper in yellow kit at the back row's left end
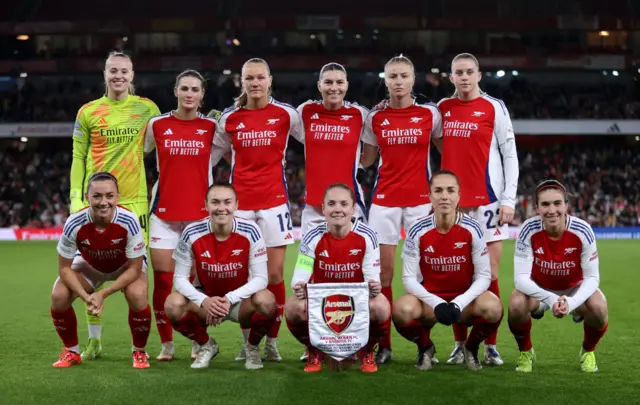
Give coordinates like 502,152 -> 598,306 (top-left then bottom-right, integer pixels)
70,52 -> 160,360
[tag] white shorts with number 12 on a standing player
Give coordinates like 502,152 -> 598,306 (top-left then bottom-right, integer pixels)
234,204 -> 295,247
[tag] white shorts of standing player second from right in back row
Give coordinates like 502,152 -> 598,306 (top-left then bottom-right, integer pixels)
369,204 -> 431,245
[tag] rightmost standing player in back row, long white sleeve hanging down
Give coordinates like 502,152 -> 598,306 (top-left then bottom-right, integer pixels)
438,53 -> 519,365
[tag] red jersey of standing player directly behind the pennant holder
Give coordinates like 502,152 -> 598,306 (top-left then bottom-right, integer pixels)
298,101 -> 369,206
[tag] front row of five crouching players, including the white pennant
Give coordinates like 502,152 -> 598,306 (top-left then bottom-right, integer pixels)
51,170 -> 608,372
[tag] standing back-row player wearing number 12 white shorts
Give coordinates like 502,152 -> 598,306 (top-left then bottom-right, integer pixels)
213,58 -> 304,361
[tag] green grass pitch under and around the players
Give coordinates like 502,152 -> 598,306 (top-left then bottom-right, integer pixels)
0,240 -> 640,405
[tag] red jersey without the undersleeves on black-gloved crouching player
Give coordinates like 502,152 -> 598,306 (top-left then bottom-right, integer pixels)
402,214 -> 491,300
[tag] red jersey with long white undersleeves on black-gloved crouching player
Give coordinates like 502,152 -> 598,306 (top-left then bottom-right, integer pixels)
402,214 -> 491,311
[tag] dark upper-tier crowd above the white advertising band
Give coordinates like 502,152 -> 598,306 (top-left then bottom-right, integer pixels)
0,75 -> 640,122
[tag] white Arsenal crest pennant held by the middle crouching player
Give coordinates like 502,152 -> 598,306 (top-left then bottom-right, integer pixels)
307,283 -> 369,361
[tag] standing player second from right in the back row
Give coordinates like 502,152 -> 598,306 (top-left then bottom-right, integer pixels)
362,56 -> 441,364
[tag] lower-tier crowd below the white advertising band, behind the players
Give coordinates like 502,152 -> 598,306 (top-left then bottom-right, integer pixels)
0,137 -> 640,228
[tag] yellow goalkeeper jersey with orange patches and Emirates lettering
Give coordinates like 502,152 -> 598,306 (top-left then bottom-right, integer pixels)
70,95 -> 160,205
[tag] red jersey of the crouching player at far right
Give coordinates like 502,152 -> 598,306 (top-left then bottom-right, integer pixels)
516,216 -> 598,291
